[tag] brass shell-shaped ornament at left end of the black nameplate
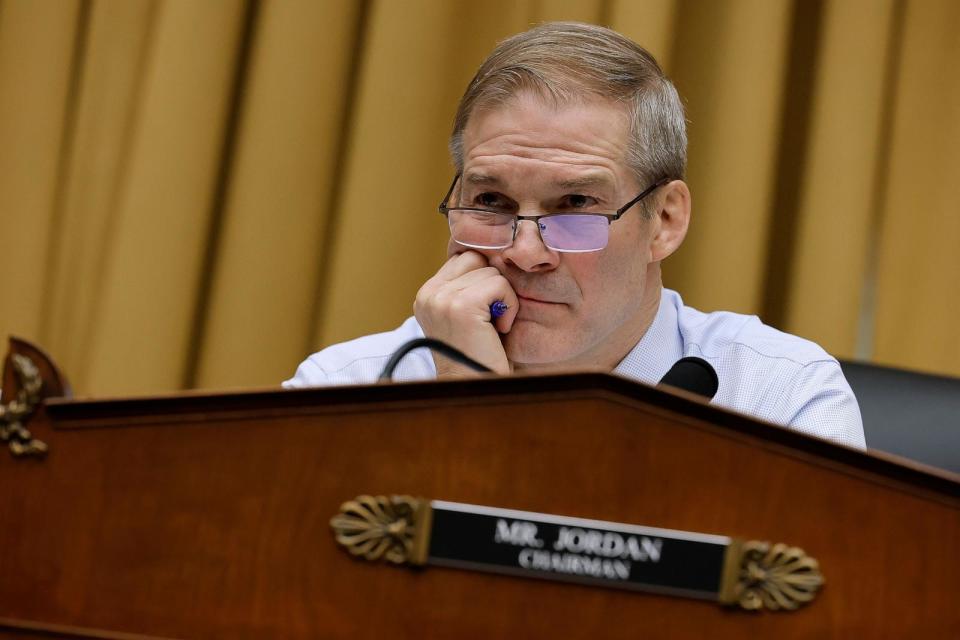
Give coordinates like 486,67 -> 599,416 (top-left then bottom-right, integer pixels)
330,495 -> 430,564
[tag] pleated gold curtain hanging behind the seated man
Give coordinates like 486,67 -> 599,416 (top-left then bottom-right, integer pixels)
0,0 -> 960,395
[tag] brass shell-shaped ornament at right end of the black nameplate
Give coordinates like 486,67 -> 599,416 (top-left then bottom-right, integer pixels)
726,540 -> 824,611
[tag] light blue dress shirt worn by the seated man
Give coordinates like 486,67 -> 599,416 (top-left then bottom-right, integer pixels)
284,289 -> 865,448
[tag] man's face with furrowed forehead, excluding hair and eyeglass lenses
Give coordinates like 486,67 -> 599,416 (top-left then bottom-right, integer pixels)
448,93 -> 660,368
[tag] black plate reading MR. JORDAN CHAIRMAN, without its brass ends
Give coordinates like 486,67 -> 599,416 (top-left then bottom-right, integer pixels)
427,500 -> 731,600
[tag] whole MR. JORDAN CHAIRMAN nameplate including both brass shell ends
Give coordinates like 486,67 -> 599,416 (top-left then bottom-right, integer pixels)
330,496 -> 823,610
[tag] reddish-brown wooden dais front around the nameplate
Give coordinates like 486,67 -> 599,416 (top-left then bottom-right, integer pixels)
0,375 -> 960,638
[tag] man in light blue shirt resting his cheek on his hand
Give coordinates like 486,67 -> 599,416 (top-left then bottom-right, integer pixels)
286,23 -> 864,447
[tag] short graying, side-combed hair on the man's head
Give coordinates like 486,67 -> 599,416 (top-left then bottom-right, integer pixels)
450,22 -> 687,210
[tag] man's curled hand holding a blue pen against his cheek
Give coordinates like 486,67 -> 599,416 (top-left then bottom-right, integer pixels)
413,251 -> 519,378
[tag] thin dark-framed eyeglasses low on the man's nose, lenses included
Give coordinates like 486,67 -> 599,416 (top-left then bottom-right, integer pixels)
439,178 -> 670,253
